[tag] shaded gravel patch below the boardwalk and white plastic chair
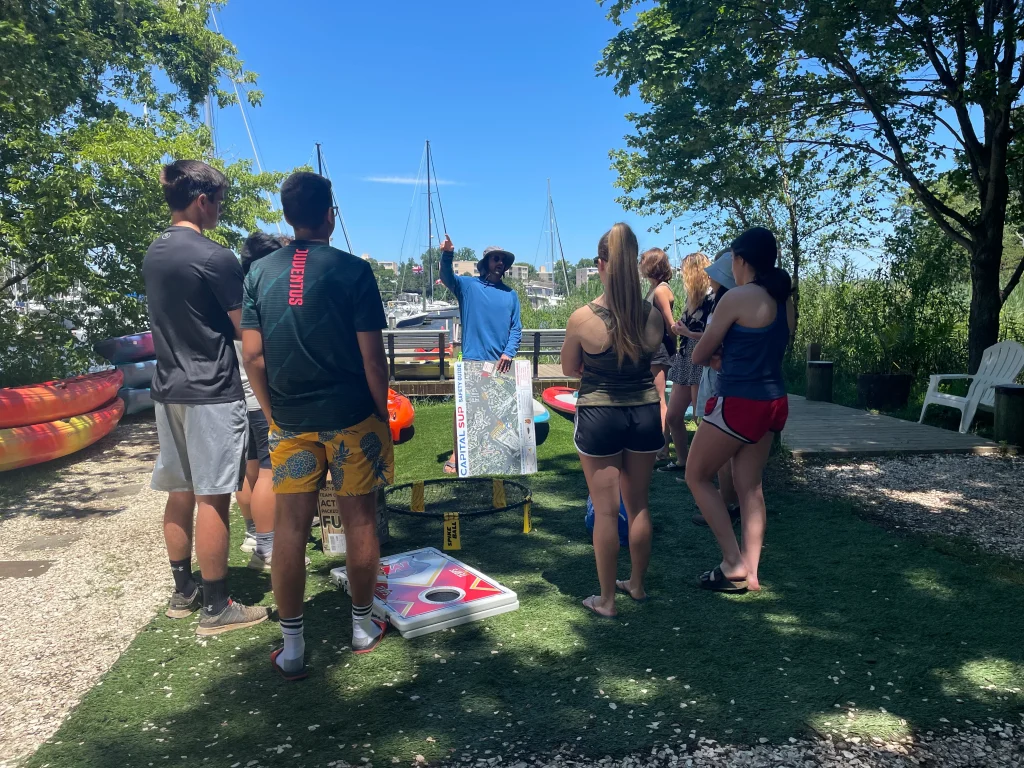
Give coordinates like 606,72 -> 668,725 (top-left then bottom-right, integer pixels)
803,456 -> 1024,559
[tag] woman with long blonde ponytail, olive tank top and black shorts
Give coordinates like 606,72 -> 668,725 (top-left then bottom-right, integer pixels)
562,224 -> 665,618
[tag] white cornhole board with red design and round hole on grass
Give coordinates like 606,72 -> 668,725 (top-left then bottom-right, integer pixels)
331,547 -> 519,639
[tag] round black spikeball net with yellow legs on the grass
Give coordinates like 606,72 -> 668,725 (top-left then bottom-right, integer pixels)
384,477 -> 532,550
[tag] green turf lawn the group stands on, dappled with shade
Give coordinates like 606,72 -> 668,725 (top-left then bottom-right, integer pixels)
29,404 -> 1024,768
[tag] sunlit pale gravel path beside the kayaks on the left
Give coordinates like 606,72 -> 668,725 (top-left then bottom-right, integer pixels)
0,419 -> 169,766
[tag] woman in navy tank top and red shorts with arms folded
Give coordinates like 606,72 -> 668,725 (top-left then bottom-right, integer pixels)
686,226 -> 794,592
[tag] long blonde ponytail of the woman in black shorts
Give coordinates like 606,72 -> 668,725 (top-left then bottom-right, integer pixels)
597,222 -> 647,368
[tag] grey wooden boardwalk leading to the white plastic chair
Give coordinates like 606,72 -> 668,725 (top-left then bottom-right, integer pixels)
782,394 -> 1000,459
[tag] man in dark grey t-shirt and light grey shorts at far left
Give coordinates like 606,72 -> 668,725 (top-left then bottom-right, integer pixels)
142,160 -> 267,636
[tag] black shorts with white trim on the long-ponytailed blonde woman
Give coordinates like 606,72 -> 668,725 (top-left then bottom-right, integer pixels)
572,402 -> 665,457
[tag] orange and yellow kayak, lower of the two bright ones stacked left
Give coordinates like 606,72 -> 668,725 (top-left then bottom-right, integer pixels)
0,398 -> 125,472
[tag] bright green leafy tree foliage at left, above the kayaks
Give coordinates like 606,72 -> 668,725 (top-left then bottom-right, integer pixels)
0,0 -> 282,386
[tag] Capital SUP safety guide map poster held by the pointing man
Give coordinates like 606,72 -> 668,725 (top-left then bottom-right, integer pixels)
455,360 -> 537,477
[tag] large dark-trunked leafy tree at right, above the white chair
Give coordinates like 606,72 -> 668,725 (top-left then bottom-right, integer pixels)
599,0 -> 1024,368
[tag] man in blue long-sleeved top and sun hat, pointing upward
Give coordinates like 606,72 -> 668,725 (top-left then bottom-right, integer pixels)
441,234 -> 522,474
